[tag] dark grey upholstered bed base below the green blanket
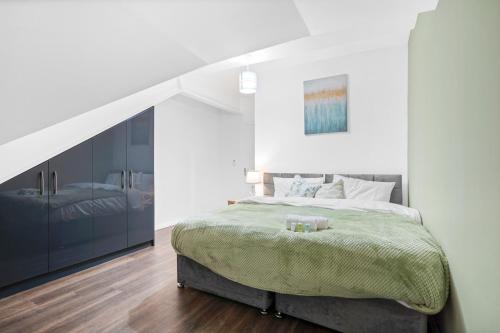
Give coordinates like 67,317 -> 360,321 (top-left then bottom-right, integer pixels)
177,255 -> 427,333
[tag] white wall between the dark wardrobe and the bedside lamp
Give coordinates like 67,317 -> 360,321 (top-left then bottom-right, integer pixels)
155,96 -> 253,229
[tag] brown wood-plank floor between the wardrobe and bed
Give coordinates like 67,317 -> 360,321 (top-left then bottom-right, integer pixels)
0,229 -> 328,333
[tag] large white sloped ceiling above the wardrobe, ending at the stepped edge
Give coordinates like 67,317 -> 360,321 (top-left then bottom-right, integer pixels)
0,0 -> 309,144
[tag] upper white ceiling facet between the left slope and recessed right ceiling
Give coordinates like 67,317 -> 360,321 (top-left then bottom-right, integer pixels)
118,0 -> 309,63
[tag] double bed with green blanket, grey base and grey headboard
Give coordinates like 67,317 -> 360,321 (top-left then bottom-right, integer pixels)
172,174 -> 449,332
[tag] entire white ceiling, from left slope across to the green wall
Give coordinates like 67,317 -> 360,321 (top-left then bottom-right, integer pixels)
0,0 -> 437,145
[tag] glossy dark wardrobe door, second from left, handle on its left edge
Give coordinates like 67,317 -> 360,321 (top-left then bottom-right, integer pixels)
49,140 -> 93,271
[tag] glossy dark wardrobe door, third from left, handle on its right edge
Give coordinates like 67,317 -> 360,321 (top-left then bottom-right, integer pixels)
92,123 -> 127,257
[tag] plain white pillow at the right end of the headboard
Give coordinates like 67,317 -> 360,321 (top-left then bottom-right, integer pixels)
333,175 -> 396,202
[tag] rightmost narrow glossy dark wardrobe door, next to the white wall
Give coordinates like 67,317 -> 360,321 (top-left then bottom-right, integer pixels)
127,108 -> 154,246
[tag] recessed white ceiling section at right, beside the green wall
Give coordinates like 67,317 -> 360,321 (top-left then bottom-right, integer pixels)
203,0 -> 439,72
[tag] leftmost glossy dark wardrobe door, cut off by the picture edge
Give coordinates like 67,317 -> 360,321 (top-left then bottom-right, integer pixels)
0,162 -> 49,287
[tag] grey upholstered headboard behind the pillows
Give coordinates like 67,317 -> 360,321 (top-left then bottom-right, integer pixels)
263,173 -> 403,205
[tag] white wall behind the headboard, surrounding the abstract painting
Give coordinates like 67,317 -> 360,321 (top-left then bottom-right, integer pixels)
255,45 -> 408,203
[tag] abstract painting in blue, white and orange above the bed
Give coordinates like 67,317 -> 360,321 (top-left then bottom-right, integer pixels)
304,75 -> 347,135
